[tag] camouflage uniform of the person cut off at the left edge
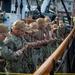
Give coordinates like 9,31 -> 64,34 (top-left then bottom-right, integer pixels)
0,42 -> 18,72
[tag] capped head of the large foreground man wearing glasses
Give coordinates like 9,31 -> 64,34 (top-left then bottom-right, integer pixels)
12,20 -> 28,37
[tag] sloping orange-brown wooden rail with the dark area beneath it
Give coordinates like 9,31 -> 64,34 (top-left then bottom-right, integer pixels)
33,28 -> 75,75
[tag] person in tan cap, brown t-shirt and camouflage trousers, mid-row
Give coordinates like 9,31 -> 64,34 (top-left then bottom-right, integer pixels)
33,18 -> 48,61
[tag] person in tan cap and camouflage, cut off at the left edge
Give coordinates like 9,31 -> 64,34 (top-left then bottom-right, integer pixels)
0,23 -> 17,72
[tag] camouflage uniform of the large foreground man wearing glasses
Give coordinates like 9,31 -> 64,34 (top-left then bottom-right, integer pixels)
5,33 -> 30,73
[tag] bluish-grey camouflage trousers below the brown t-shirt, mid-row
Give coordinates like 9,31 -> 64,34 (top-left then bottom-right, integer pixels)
32,48 -> 43,68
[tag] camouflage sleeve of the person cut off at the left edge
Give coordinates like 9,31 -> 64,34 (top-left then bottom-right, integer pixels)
1,46 -> 18,60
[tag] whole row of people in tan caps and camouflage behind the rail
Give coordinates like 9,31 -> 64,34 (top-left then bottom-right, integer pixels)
0,16 -> 73,73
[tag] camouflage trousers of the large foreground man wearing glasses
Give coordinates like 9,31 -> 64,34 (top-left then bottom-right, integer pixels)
6,56 -> 30,73
